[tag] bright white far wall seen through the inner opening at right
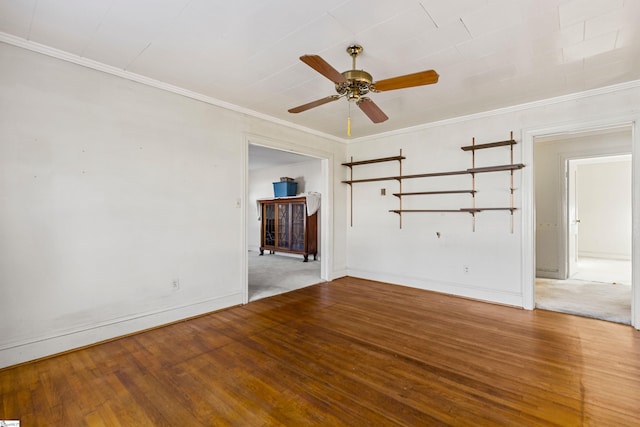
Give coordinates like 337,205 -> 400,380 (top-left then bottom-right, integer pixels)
577,157 -> 631,260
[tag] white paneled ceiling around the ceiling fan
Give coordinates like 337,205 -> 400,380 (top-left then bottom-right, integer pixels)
0,0 -> 640,139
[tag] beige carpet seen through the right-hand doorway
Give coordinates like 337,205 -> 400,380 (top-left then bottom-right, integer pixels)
535,258 -> 631,325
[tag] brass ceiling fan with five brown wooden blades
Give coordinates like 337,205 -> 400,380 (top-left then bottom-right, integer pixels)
288,44 -> 439,128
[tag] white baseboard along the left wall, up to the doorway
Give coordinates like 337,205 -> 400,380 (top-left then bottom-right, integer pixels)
0,293 -> 242,369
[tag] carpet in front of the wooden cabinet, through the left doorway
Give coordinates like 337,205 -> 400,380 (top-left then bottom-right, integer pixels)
249,251 -> 323,301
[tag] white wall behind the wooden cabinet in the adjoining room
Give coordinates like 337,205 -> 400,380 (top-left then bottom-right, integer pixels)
247,159 -> 326,255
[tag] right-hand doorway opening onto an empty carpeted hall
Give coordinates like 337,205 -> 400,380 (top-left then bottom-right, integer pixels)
534,126 -> 632,324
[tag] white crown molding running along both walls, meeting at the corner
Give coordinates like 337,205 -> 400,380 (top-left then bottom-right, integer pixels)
5,31 -> 640,144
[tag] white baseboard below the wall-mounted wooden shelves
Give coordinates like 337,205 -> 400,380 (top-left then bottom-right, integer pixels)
348,269 -> 524,307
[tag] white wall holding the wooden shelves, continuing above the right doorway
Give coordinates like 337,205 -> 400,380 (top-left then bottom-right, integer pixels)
344,86 -> 640,306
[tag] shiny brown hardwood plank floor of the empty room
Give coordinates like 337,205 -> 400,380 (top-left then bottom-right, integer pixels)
0,278 -> 640,426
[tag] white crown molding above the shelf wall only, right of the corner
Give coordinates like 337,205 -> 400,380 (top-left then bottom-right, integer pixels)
348,80 -> 640,143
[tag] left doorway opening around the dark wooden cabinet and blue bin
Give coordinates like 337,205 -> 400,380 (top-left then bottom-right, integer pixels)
246,141 -> 326,302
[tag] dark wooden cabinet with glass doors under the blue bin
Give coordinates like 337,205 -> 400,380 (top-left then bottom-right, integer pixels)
259,197 -> 318,262
